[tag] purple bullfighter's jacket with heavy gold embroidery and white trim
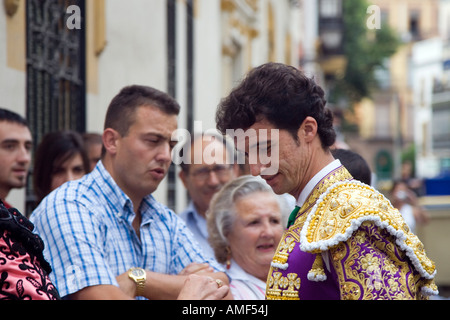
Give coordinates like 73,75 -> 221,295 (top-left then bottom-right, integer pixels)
266,166 -> 437,299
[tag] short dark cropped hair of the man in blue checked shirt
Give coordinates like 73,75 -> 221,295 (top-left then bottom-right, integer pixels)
104,85 -> 180,136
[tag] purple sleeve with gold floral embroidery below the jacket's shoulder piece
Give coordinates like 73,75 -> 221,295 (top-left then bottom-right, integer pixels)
331,222 -> 430,300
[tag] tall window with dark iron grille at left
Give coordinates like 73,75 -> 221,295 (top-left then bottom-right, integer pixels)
26,0 -> 86,213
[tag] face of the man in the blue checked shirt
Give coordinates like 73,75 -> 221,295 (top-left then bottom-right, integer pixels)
110,106 -> 177,197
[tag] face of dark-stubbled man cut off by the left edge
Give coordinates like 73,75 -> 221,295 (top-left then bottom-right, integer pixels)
0,121 -> 32,198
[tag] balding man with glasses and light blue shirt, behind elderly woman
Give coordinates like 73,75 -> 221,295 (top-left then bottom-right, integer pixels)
179,134 -> 238,257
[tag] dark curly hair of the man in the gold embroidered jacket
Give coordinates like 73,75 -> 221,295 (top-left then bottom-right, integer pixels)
216,62 -> 336,149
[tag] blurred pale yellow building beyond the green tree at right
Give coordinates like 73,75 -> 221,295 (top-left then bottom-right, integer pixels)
342,0 -> 445,190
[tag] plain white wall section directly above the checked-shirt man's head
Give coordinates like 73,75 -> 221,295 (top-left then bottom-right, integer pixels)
87,0 -> 167,131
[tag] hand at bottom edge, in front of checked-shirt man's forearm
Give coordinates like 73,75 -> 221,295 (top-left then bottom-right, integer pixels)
177,274 -> 230,300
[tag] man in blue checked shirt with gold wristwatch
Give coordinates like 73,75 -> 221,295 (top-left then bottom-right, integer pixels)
31,86 -> 230,299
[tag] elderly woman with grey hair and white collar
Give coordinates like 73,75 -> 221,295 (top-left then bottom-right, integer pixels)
206,175 -> 289,300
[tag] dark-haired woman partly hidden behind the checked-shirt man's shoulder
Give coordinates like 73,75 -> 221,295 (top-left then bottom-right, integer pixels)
33,130 -> 89,204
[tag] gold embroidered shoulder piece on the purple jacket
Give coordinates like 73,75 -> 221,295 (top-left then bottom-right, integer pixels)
300,182 -> 436,279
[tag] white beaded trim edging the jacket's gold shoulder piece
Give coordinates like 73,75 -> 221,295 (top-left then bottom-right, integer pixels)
300,181 -> 436,279
